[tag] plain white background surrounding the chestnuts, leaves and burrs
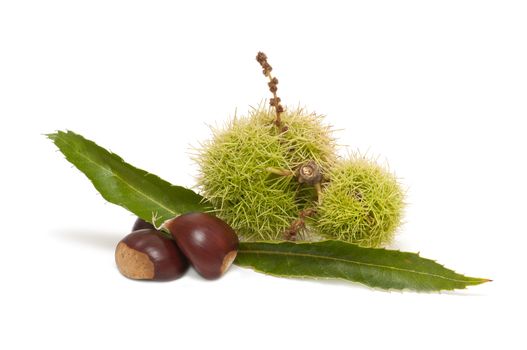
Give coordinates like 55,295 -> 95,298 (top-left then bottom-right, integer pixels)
0,0 -> 527,349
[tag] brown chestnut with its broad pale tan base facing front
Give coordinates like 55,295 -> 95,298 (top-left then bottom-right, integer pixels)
115,229 -> 189,281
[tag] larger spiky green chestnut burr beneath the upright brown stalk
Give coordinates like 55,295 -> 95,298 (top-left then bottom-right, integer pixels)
195,107 -> 335,240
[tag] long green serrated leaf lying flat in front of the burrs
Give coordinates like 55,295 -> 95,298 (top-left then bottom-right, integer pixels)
235,240 -> 489,291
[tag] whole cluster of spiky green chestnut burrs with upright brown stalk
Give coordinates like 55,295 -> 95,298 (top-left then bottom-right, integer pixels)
196,52 -> 404,246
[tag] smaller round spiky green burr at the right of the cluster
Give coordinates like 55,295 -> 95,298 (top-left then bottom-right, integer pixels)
315,155 -> 404,247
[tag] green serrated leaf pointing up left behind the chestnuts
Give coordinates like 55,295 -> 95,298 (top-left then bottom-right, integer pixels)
46,131 -> 211,226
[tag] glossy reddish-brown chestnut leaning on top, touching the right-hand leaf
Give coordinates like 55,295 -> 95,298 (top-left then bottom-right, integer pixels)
163,213 -> 238,279
